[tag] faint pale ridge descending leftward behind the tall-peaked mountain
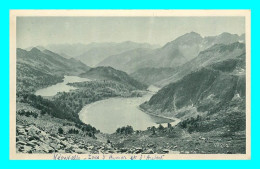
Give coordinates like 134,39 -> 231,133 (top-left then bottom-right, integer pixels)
75,41 -> 157,66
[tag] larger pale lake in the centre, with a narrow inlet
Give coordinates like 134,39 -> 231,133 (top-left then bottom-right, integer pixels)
79,86 -> 180,134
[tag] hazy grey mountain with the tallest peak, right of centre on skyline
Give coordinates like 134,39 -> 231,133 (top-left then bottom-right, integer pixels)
98,32 -> 243,73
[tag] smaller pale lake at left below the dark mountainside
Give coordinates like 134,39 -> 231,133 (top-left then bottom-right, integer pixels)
35,76 -> 91,96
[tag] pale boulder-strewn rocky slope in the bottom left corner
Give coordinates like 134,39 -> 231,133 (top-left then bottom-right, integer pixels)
16,125 -> 90,154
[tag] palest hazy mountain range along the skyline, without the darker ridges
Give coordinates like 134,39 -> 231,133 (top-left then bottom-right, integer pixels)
23,32 -> 245,73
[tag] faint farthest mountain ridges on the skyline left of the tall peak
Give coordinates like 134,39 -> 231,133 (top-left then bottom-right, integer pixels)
26,41 -> 160,67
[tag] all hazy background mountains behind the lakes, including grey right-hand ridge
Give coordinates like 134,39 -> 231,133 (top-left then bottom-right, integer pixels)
22,32 -> 245,90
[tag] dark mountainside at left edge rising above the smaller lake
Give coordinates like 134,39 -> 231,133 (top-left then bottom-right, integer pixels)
16,48 -> 90,92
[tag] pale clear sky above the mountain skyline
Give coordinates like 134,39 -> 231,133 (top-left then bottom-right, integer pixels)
16,17 -> 245,48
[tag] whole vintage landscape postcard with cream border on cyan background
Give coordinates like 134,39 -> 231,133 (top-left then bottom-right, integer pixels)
10,10 -> 251,160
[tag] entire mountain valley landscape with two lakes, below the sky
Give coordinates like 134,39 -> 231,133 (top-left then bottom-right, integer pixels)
16,32 -> 246,154
